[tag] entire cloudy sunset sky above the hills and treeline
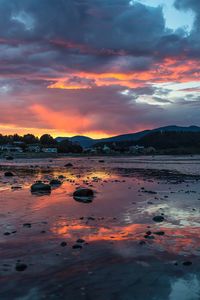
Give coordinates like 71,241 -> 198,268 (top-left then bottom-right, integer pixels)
0,0 -> 200,137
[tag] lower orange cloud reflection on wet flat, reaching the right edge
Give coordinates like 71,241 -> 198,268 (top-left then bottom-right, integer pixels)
51,220 -> 200,255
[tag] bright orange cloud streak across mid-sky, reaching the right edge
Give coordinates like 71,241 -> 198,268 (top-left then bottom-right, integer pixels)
48,58 -> 200,89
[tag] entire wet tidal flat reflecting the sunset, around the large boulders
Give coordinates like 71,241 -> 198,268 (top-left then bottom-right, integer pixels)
0,156 -> 200,300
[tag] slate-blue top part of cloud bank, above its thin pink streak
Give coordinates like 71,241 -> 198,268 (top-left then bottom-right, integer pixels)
0,0 -> 165,49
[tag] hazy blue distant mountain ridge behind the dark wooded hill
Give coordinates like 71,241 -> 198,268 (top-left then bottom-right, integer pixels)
56,125 -> 200,148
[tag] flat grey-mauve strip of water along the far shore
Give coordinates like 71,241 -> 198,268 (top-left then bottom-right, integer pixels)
0,155 -> 200,174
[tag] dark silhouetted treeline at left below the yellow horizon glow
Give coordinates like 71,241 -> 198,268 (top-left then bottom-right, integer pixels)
0,134 -> 83,153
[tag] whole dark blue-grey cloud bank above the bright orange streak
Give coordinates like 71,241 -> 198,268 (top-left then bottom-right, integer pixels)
0,0 -> 191,76
